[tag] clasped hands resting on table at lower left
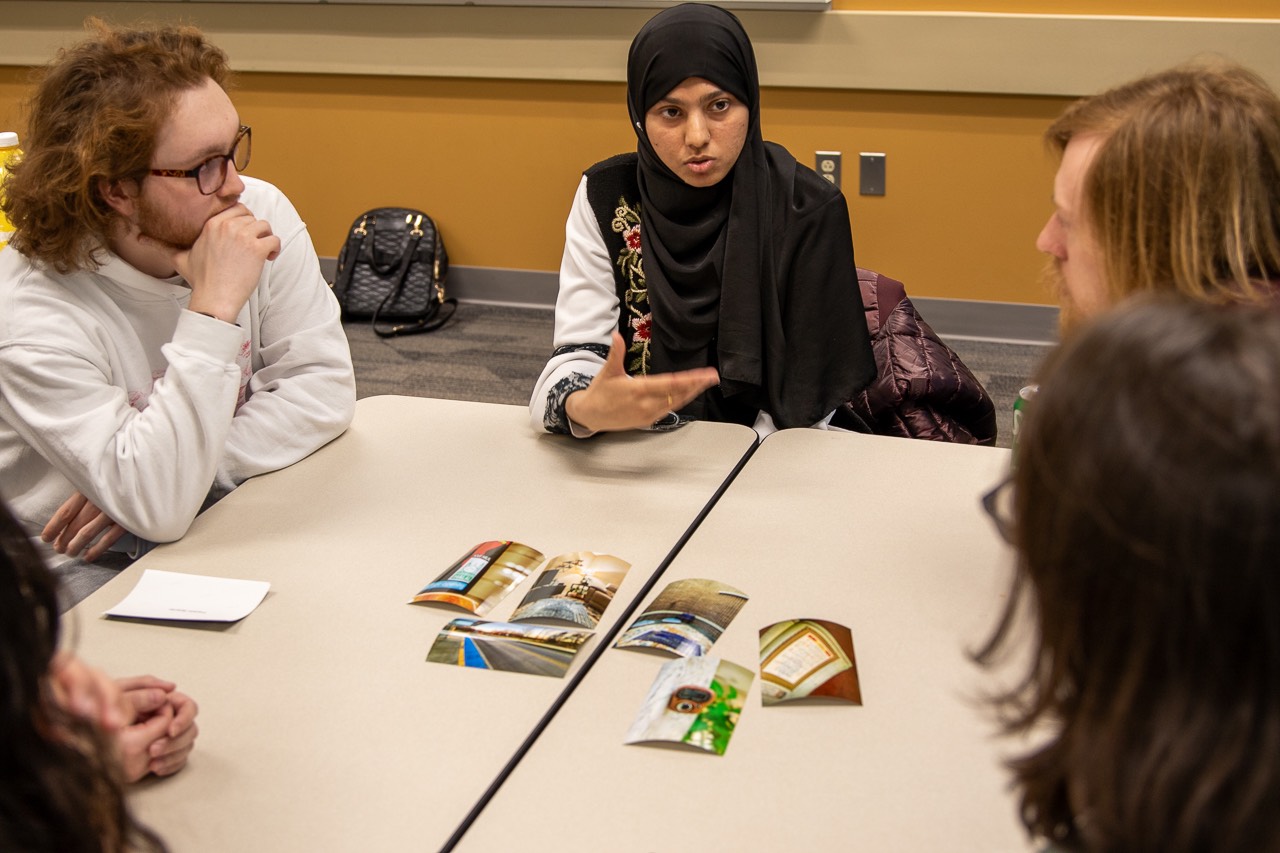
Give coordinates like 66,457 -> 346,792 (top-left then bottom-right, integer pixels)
50,652 -> 200,783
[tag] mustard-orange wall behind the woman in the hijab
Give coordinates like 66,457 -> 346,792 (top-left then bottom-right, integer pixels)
0,0 -> 1280,304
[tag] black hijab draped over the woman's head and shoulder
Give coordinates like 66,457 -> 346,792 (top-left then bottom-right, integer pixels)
627,3 -> 874,427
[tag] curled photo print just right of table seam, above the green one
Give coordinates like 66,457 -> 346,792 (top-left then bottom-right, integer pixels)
613,578 -> 748,657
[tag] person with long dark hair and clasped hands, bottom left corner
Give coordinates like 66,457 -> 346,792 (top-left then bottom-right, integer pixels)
0,494 -> 195,853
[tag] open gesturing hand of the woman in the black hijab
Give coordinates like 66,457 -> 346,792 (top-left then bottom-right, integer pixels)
564,332 -> 719,433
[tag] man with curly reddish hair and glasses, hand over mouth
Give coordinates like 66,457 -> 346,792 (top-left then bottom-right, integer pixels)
0,19 -> 356,592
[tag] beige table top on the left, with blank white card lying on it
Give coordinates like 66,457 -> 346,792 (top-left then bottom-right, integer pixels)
68,397 -> 755,852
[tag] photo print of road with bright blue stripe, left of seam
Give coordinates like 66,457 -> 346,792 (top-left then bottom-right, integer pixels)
426,619 -> 593,678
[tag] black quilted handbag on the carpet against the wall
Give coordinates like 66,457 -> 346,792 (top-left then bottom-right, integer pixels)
333,207 -> 458,338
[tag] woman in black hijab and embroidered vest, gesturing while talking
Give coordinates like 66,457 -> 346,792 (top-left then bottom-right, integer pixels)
530,4 -> 876,435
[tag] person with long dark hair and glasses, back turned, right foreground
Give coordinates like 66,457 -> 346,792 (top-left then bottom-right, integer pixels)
977,295 -> 1280,853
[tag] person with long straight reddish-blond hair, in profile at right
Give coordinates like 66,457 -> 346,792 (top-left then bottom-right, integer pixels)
1036,60 -> 1280,332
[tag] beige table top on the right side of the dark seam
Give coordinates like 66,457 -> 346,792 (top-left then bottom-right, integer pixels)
457,430 -> 1027,852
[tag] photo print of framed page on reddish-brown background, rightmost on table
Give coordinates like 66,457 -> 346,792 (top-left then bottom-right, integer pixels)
760,619 -> 863,704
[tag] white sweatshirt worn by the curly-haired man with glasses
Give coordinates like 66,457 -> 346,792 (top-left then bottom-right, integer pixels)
0,178 -> 356,561
